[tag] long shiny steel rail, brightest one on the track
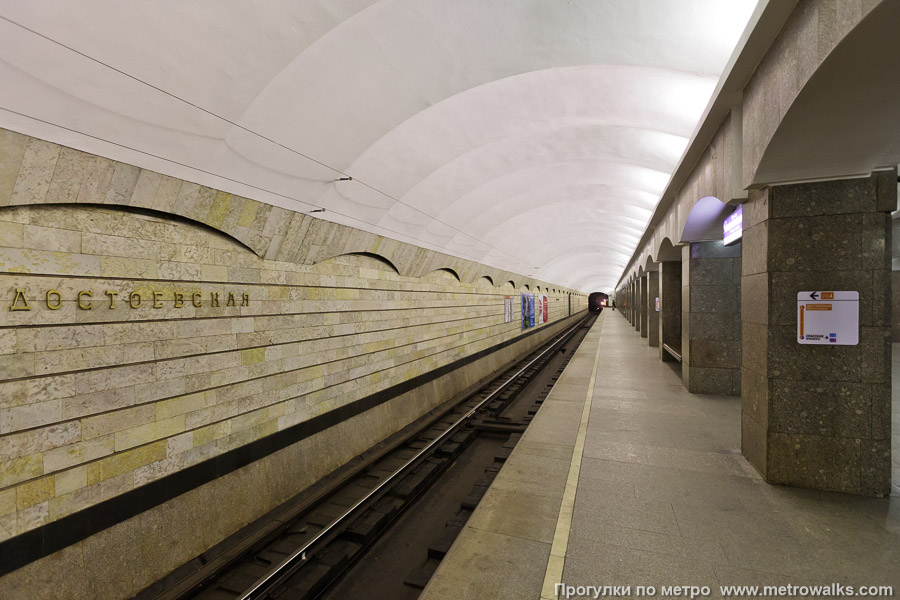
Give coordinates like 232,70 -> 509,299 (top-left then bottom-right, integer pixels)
238,317 -> 587,600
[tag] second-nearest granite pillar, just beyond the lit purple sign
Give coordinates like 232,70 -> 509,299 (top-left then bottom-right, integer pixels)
681,241 -> 741,396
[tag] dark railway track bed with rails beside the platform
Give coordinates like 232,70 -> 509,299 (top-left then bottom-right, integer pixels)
136,315 -> 596,600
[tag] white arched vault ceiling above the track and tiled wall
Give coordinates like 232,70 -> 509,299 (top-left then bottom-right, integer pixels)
0,0 -> 756,291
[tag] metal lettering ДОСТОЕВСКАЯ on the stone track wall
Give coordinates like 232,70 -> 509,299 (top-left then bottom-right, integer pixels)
9,288 -> 250,311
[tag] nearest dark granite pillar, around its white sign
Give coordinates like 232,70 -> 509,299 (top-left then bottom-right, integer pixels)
741,170 -> 897,496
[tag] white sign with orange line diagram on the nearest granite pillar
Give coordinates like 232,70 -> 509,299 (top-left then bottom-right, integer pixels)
797,291 -> 859,346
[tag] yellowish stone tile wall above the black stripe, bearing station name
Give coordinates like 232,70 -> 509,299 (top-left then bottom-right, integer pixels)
0,130 -> 586,541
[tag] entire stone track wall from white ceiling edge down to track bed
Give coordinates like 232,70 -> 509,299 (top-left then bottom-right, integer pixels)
0,130 -> 587,598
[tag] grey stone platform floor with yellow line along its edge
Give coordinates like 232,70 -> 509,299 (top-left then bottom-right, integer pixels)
420,311 -> 900,600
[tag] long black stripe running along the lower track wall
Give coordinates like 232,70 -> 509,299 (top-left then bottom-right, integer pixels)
0,314 -> 579,576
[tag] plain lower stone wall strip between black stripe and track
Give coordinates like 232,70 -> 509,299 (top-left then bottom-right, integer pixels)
0,316 -> 578,600
